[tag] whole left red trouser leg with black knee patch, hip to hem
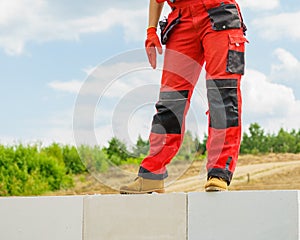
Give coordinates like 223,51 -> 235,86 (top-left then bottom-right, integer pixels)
139,5 -> 203,179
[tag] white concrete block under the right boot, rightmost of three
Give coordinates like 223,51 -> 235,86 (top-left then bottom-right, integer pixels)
188,191 -> 300,240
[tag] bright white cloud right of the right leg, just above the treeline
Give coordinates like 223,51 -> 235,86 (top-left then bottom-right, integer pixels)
242,69 -> 300,132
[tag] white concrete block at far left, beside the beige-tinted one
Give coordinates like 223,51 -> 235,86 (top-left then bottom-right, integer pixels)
0,197 -> 83,240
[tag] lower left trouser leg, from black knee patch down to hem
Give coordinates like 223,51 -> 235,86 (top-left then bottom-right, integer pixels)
139,89 -> 190,179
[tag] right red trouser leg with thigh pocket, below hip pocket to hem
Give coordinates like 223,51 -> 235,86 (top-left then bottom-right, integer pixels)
204,29 -> 246,185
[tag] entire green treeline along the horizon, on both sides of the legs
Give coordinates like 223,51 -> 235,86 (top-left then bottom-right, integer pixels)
0,123 -> 300,196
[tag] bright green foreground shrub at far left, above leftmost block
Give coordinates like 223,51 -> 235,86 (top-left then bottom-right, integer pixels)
0,144 -> 73,196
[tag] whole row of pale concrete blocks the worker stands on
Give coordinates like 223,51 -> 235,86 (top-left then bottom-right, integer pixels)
0,191 -> 300,240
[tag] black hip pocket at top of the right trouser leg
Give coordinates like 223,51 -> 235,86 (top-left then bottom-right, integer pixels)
207,3 -> 242,31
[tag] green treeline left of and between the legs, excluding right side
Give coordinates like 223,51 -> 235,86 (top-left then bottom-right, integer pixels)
0,132 -> 204,196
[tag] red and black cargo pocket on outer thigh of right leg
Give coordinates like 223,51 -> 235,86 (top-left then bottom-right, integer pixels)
226,35 -> 248,75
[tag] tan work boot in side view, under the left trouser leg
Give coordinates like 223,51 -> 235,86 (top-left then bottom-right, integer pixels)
120,177 -> 165,194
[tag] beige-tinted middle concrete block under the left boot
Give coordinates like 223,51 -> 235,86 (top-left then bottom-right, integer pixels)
84,193 -> 187,240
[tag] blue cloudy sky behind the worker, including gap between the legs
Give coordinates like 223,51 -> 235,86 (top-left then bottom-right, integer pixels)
0,0 -> 300,146
